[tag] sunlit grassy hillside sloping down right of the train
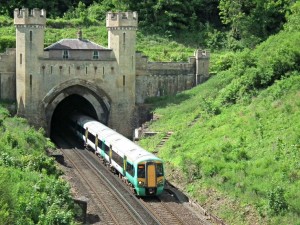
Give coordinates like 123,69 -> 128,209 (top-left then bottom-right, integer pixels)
140,6 -> 300,225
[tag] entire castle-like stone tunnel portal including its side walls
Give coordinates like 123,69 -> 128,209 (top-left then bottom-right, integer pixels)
0,8 -> 209,137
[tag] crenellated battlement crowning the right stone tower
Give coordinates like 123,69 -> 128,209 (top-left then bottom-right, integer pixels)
106,11 -> 138,28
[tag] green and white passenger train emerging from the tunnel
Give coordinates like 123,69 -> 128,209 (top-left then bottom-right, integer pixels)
69,113 -> 165,196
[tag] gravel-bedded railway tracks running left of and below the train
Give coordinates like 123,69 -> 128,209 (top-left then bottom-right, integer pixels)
54,132 -> 213,225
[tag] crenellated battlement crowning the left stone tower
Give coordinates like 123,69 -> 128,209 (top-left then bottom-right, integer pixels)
14,8 -> 46,25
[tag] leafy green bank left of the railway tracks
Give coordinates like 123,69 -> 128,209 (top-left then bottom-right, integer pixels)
0,105 -> 75,225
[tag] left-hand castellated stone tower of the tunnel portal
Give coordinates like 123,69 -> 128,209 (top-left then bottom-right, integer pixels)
14,8 -> 46,118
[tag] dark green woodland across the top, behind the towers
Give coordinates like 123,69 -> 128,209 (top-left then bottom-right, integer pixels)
0,0 -> 296,50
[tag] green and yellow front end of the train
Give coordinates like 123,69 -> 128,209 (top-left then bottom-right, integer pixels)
135,157 -> 165,196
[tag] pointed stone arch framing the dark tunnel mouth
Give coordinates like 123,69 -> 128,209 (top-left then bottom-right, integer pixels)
42,79 -> 111,136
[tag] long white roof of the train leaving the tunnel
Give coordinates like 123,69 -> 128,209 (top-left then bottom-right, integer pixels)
76,116 -> 160,162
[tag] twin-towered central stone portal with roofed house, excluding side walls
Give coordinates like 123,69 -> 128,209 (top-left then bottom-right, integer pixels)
14,9 -> 137,136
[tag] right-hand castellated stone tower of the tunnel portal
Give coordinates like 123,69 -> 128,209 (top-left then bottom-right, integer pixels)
106,12 -> 138,132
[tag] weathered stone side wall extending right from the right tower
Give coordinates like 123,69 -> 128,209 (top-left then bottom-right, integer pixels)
136,53 -> 196,104
